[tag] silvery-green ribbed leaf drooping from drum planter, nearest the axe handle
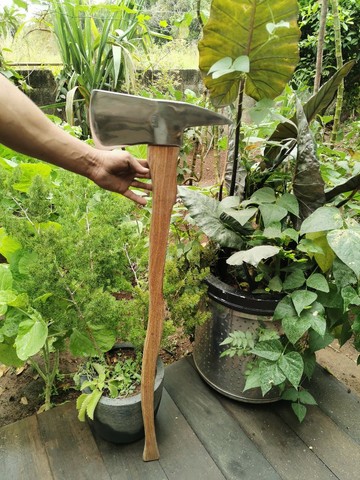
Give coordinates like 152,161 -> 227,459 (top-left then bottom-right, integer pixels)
179,187 -> 243,248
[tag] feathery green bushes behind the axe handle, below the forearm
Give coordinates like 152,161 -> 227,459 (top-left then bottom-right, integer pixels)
0,115 -> 211,408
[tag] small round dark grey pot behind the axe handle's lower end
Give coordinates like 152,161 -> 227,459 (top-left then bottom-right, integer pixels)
87,344 -> 164,443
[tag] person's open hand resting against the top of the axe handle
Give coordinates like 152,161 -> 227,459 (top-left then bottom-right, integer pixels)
89,149 -> 152,205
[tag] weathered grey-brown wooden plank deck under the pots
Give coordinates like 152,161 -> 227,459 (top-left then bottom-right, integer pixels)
0,358 -> 360,480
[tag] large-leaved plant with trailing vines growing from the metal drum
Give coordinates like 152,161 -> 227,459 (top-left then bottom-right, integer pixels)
180,0 -> 360,421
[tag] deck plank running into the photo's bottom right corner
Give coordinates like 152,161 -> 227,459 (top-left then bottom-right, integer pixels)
276,403 -> 360,480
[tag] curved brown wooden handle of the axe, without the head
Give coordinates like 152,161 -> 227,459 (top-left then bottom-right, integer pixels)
141,146 -> 179,462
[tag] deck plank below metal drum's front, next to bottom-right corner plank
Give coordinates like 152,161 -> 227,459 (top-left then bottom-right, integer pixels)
219,395 -> 336,480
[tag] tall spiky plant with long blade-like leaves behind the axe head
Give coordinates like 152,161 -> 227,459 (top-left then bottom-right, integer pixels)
51,0 -> 165,137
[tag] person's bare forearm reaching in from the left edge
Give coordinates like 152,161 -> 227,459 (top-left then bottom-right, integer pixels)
0,74 -> 95,177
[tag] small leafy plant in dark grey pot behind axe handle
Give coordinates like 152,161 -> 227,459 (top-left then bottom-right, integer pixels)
76,343 -> 164,443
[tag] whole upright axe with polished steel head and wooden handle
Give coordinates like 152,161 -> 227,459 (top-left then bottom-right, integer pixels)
90,90 -> 231,461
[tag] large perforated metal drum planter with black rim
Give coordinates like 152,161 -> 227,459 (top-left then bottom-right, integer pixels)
193,276 -> 280,403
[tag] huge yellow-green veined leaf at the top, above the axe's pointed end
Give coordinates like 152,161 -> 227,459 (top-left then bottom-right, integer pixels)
199,0 -> 300,107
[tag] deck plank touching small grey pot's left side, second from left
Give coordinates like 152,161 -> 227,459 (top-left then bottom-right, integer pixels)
35,402 -> 111,480
